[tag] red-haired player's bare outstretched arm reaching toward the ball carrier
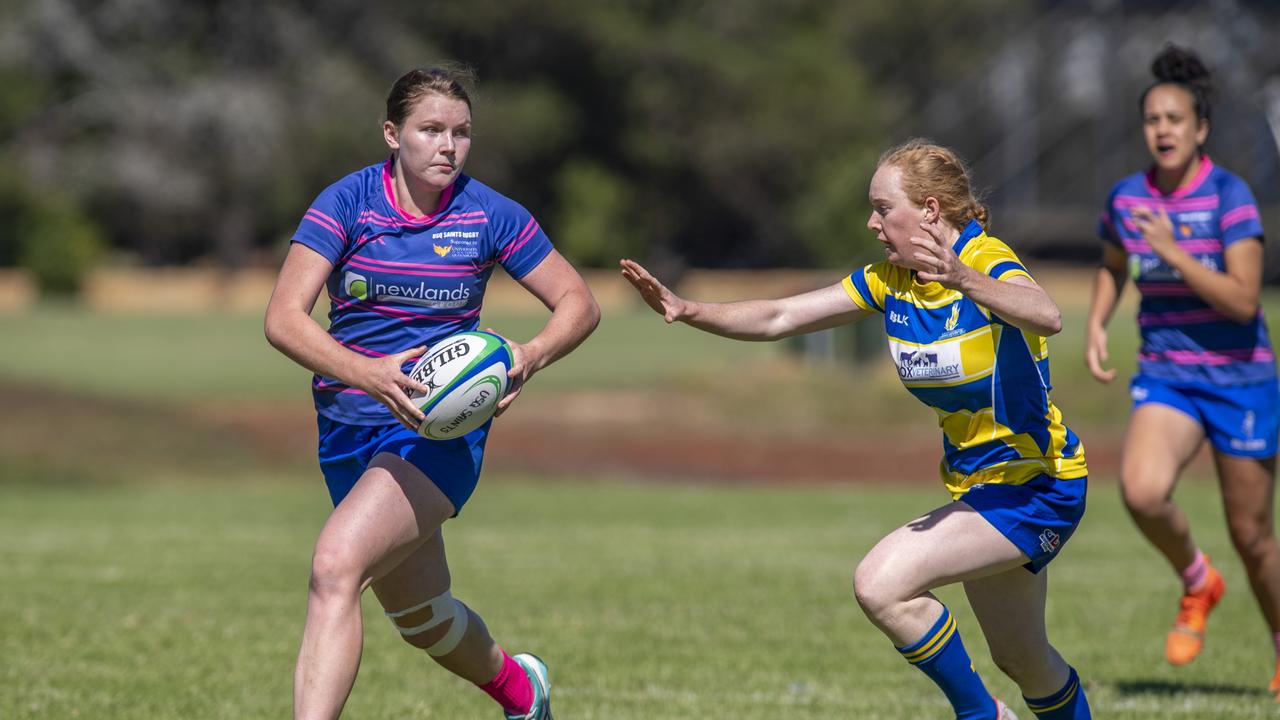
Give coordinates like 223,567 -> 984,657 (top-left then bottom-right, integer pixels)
621,259 -> 870,341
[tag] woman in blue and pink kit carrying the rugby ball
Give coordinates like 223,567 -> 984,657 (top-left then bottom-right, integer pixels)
266,68 -> 599,720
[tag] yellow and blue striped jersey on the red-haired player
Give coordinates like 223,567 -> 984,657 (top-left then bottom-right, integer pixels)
844,222 -> 1087,497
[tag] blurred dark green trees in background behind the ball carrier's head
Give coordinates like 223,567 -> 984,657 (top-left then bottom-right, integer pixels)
0,0 -> 1025,275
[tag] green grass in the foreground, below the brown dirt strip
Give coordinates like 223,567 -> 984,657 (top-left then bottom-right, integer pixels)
0,478 -> 1275,720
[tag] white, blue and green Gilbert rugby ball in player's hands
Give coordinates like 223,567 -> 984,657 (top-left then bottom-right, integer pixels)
408,332 -> 511,439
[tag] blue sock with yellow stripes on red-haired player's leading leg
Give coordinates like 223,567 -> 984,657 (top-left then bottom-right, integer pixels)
897,605 -> 996,720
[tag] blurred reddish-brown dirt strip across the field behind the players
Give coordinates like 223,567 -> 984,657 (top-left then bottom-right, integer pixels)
0,383 -> 1212,484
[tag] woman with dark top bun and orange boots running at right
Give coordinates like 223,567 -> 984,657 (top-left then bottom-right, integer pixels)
1084,45 -> 1280,693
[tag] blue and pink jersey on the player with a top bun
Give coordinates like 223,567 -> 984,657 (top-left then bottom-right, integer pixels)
1098,156 -> 1276,384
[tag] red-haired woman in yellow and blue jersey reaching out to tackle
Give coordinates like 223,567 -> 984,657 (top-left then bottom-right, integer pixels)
622,140 -> 1091,720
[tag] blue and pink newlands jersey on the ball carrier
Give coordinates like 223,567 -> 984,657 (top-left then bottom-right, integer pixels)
293,159 -> 552,425
